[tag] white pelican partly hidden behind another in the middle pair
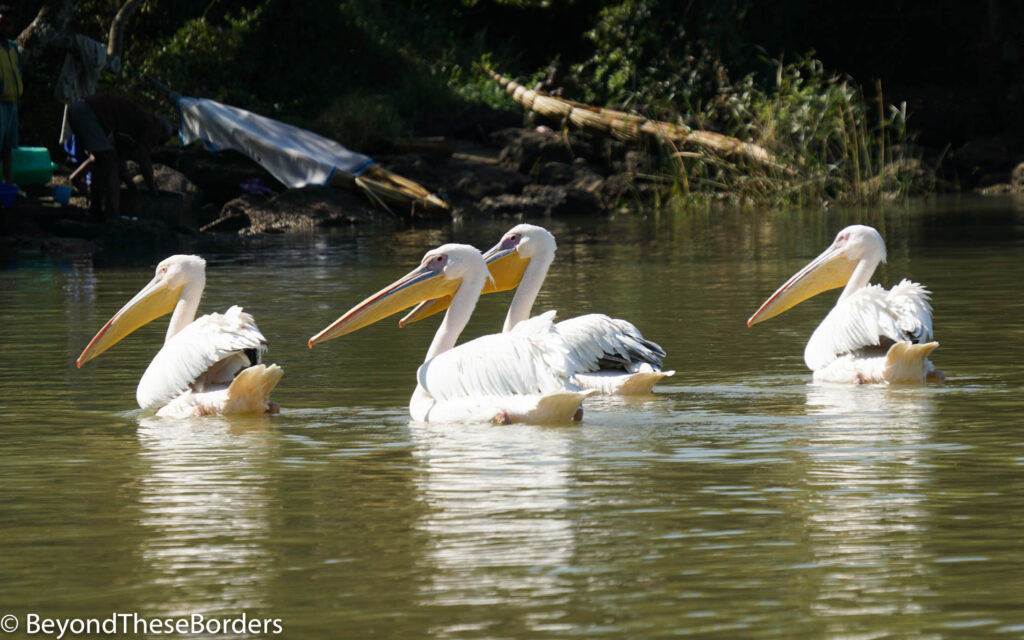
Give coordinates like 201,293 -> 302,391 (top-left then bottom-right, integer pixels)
399,224 -> 676,395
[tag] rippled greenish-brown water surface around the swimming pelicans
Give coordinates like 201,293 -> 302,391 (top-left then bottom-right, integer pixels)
0,200 -> 1024,639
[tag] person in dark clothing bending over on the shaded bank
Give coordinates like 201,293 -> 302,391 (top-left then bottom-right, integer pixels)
68,95 -> 174,220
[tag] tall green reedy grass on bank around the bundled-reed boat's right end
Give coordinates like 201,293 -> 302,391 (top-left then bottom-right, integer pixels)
577,58 -> 930,207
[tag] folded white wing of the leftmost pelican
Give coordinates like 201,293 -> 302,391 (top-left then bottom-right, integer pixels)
135,306 -> 266,410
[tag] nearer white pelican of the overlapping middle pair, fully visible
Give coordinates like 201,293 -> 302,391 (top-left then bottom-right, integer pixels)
309,245 -> 590,424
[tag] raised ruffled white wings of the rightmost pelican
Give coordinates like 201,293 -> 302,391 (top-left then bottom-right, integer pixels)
804,280 -> 932,371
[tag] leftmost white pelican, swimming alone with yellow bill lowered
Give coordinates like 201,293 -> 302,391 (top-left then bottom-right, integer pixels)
77,255 -> 284,418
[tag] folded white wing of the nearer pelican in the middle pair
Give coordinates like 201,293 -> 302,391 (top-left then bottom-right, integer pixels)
417,311 -> 577,402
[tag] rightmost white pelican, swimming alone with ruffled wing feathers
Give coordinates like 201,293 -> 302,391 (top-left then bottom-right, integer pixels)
746,224 -> 943,384
